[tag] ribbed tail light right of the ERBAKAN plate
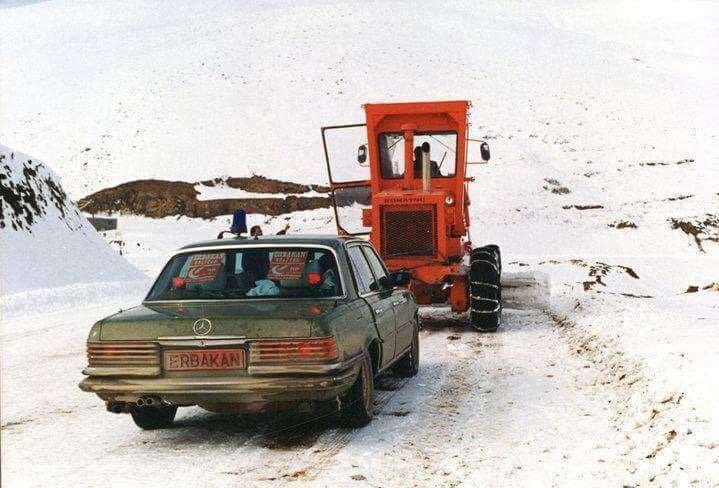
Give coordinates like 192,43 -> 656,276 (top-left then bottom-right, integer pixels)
250,337 -> 339,364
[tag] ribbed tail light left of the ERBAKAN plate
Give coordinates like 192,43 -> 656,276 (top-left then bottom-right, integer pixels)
87,341 -> 160,367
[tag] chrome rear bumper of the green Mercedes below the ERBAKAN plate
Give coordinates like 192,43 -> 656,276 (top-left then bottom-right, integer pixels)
79,354 -> 362,404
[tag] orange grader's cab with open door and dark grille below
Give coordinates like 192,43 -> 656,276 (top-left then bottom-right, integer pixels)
322,101 -> 489,269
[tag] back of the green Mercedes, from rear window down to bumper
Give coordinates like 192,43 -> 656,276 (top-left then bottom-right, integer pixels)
80,243 -> 362,412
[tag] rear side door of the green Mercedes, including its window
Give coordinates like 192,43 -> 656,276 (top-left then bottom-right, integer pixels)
347,244 -> 396,368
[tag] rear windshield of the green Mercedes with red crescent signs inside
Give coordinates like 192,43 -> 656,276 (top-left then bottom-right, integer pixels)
146,247 -> 342,301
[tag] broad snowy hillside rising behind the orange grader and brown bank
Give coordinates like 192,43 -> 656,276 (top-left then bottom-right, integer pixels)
0,0 -> 719,198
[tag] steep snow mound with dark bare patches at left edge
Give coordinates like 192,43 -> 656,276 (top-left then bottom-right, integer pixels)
0,146 -> 145,312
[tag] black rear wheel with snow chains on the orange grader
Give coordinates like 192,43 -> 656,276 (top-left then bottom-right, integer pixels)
469,244 -> 502,332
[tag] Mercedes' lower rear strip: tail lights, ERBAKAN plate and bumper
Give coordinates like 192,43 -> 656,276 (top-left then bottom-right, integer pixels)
80,336 -> 358,411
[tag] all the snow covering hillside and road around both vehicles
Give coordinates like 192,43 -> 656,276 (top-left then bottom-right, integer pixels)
0,0 -> 719,486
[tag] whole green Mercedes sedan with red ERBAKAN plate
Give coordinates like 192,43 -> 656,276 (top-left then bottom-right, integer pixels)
80,235 -> 419,429
